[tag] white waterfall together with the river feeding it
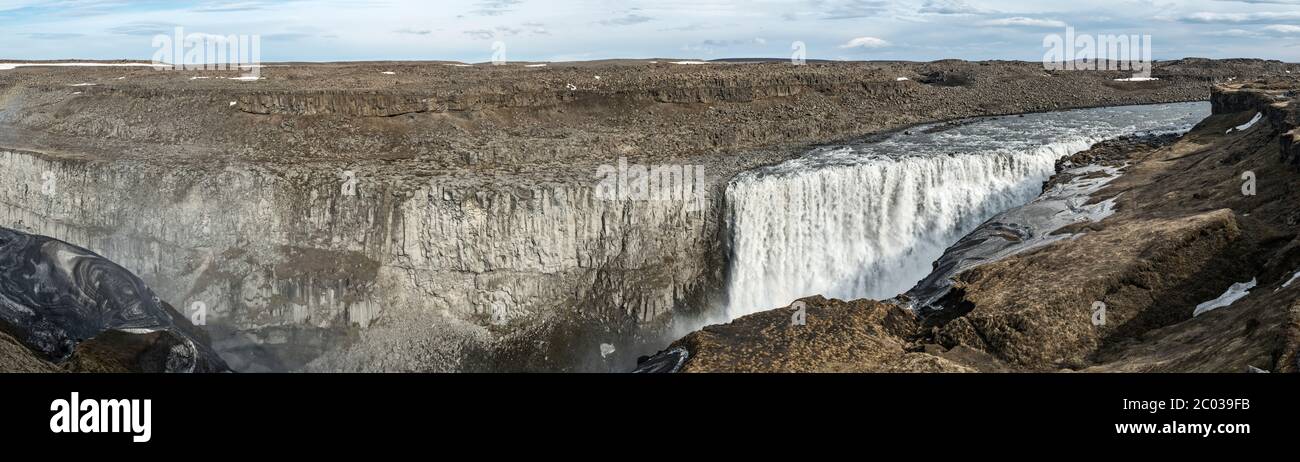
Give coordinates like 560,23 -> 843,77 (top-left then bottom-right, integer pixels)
725,103 -> 1209,319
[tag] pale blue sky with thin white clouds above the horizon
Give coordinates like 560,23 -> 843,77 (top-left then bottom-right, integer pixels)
0,0 -> 1300,62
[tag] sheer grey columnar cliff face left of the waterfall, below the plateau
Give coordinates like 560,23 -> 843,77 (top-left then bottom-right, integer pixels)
0,151 -> 716,370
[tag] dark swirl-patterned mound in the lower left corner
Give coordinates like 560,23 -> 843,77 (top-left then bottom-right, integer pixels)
0,228 -> 226,372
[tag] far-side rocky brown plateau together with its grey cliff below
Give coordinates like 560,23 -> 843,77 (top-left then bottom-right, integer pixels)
0,60 -> 1300,371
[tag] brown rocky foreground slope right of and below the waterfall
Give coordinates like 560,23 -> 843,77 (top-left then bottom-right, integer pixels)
660,78 -> 1300,372
